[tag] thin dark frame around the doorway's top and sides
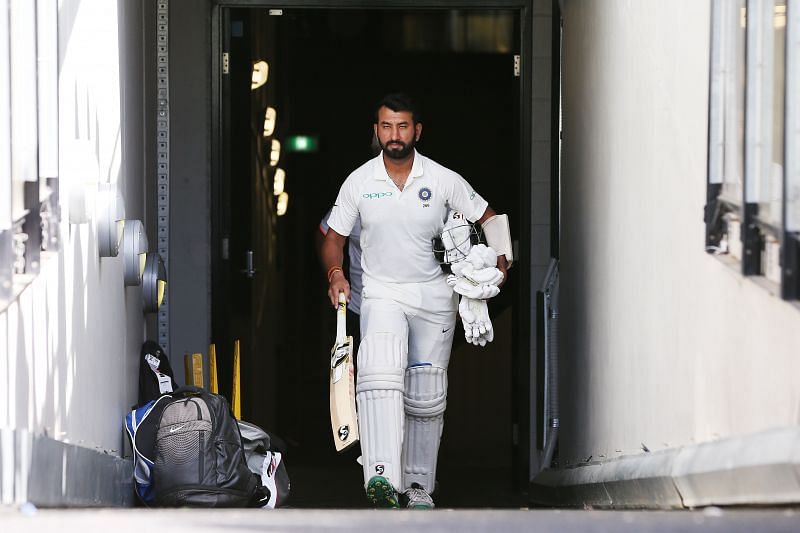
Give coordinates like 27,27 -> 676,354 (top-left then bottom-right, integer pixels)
210,0 -> 536,491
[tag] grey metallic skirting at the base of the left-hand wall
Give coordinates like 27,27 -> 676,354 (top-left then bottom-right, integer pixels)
0,428 -> 134,507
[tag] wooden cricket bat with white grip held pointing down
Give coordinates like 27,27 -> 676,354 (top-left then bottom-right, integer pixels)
331,292 -> 358,452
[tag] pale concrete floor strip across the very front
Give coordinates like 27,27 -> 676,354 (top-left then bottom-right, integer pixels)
0,506 -> 800,533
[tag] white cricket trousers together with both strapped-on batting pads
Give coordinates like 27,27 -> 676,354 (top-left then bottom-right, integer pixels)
356,275 -> 458,492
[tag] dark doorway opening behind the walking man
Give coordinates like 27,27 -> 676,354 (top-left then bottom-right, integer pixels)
212,8 -> 530,507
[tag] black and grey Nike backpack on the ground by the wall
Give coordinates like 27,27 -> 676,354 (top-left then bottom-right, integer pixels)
125,387 -> 270,507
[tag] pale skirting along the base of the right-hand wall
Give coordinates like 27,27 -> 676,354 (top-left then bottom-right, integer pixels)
530,426 -> 800,509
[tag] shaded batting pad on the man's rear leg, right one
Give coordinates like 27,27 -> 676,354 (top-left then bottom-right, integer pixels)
403,364 -> 447,492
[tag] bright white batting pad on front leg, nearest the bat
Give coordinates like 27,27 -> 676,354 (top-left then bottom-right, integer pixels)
356,333 -> 408,490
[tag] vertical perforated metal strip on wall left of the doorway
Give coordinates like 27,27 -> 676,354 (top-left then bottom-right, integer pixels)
156,0 -> 169,353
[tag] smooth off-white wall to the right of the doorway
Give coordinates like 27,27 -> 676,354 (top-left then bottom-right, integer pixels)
559,0 -> 800,463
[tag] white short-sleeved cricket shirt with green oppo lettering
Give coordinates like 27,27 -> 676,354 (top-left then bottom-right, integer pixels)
328,151 -> 488,283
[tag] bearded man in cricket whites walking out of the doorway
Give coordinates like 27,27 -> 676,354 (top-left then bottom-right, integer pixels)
322,94 -> 511,508
